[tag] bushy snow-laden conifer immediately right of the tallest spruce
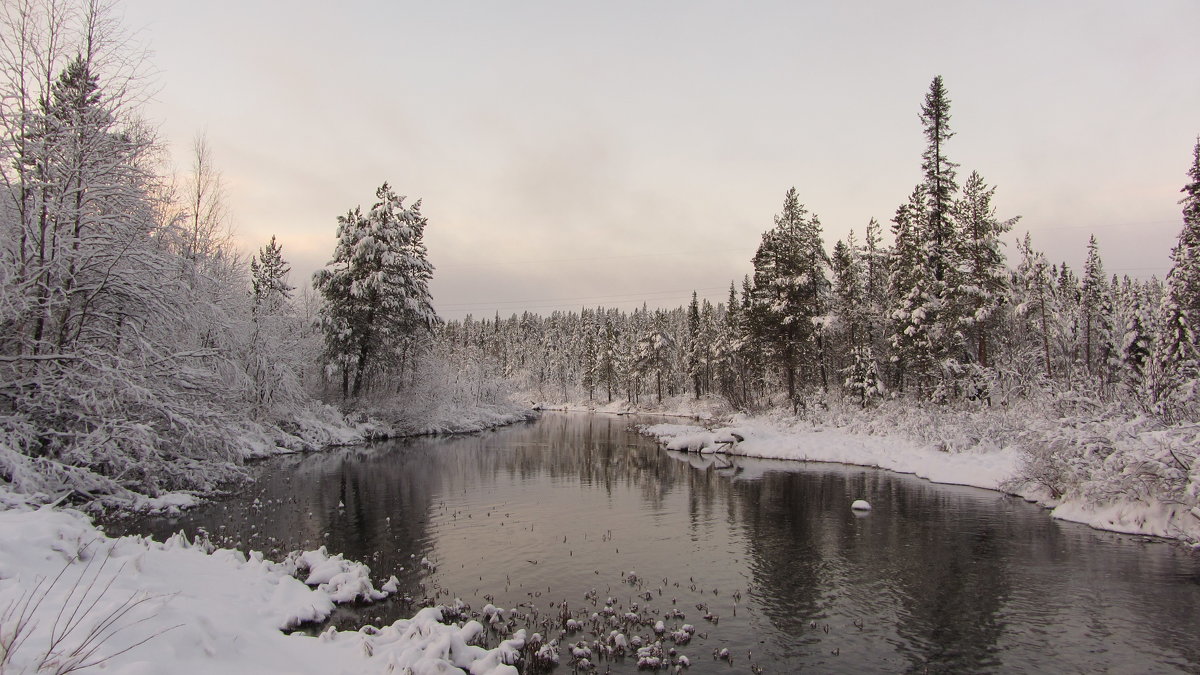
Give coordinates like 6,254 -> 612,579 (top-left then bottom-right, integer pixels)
954,172 -> 1019,368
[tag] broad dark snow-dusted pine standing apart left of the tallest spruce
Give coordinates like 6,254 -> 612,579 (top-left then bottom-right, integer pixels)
746,187 -> 828,405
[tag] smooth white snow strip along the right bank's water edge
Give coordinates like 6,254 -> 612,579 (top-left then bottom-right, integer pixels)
642,416 -> 1200,545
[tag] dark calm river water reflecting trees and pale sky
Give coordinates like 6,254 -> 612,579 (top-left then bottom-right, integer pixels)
108,413 -> 1200,673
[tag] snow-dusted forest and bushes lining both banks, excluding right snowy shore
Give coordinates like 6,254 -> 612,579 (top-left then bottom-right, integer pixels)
0,2 -> 1200,528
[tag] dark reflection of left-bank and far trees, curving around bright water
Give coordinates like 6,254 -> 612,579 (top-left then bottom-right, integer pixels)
124,414 -> 685,566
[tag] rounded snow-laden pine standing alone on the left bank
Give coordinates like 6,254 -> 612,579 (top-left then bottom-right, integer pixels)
313,183 -> 440,399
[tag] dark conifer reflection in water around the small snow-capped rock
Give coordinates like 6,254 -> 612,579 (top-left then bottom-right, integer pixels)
720,466 -> 1008,671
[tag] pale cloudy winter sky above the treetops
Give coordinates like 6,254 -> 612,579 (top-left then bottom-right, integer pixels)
121,0 -> 1200,318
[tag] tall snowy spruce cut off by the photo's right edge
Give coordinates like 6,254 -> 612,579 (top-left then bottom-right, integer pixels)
1150,139 -> 1200,422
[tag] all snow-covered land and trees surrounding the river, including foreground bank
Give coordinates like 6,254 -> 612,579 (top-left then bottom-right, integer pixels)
0,0 -> 1200,675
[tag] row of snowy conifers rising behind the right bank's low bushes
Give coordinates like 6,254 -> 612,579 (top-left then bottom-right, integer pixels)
442,77 -> 1200,422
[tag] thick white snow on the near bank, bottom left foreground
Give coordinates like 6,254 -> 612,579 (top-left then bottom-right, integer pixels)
0,507 -> 524,675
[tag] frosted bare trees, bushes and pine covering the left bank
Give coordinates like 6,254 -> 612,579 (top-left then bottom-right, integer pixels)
0,0 -> 528,508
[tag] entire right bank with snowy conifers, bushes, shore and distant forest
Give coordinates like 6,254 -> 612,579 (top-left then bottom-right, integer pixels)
443,77 -> 1200,542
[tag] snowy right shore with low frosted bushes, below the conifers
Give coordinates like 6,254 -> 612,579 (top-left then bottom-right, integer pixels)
643,398 -> 1200,543
